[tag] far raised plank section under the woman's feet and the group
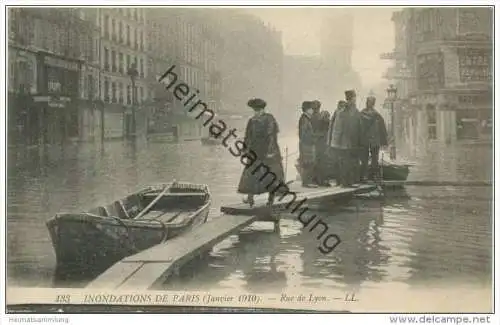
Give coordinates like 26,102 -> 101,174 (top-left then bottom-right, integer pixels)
220,184 -> 376,217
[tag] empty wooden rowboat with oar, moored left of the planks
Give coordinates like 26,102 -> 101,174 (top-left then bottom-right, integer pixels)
47,182 -> 211,273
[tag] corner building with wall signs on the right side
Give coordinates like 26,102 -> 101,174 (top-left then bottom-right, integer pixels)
385,7 -> 493,143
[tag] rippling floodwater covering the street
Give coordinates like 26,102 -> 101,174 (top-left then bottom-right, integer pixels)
7,137 -> 493,292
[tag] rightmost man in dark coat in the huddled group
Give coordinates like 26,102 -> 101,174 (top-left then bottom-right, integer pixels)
361,96 -> 388,181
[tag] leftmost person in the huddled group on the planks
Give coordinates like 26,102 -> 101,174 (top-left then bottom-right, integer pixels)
299,101 -> 317,187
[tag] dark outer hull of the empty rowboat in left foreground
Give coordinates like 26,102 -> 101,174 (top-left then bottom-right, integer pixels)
47,181 -> 211,280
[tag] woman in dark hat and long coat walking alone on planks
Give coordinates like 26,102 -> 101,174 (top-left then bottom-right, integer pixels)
238,98 -> 285,206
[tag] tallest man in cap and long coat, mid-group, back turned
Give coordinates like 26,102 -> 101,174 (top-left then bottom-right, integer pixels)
329,90 -> 361,187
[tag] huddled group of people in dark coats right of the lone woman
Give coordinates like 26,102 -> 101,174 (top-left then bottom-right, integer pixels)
298,90 -> 388,187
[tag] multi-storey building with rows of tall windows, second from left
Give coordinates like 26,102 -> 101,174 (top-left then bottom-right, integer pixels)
80,8 -> 149,138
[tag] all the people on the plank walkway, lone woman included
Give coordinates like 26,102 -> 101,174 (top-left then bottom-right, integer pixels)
234,90 -> 388,205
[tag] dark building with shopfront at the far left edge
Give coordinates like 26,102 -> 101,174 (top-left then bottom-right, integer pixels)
8,8 -> 96,144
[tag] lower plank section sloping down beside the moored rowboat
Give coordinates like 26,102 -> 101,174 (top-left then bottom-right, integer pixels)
87,215 -> 257,290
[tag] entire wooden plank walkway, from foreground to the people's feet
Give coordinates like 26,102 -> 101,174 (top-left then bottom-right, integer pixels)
87,181 -> 375,290
